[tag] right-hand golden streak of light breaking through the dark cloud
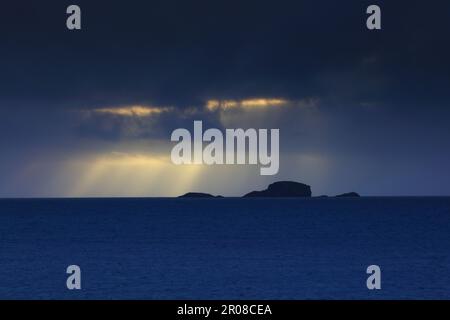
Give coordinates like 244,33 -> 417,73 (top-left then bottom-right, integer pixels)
206,98 -> 289,111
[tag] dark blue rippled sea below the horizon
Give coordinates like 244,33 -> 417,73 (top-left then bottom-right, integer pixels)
0,198 -> 450,299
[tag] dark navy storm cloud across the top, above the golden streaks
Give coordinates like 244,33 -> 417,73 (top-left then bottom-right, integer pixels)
0,0 -> 450,107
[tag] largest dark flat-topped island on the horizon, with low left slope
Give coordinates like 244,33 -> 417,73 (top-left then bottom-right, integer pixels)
244,181 -> 312,198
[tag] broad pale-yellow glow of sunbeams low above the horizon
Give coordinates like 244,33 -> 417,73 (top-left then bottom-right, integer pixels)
65,153 -> 203,197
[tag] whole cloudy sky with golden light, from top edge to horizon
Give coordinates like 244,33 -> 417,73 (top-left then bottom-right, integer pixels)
0,0 -> 450,197
